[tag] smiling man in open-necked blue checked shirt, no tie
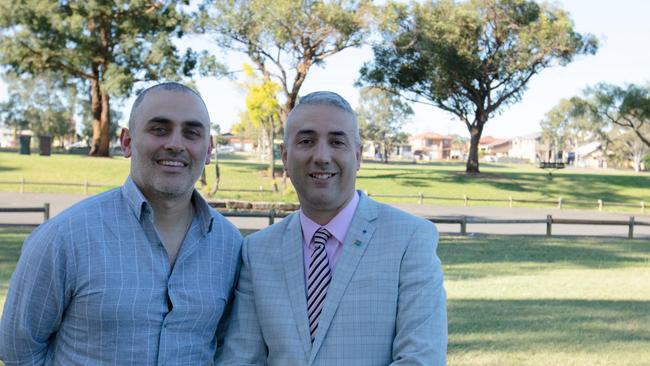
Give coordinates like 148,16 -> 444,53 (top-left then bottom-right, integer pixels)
0,83 -> 242,365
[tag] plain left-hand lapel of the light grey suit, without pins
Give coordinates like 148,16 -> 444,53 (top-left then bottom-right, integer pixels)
282,214 -> 311,358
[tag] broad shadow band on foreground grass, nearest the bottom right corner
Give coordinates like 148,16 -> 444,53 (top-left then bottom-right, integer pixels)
448,299 -> 650,354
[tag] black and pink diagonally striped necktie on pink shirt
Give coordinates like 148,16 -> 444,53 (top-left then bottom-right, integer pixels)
307,227 -> 332,342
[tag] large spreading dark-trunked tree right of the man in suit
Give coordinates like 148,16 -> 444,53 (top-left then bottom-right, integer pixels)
359,0 -> 597,173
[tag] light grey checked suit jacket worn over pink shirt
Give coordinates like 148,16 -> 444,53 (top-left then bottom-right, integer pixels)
217,194 -> 447,366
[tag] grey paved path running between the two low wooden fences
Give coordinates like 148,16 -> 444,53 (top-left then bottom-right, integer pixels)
0,192 -> 650,241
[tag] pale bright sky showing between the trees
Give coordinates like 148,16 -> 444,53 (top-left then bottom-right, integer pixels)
0,0 -> 650,138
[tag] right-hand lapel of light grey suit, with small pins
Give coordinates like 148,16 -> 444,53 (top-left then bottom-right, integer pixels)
309,194 -> 377,364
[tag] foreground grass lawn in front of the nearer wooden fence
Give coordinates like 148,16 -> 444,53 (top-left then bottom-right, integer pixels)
0,228 -> 650,366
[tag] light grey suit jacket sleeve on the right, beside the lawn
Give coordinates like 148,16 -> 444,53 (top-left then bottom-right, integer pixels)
391,222 -> 447,366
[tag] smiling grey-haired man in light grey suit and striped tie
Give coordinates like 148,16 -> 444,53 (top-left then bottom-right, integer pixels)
218,92 -> 447,366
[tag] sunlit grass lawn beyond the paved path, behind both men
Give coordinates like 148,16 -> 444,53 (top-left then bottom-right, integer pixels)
0,153 -> 650,212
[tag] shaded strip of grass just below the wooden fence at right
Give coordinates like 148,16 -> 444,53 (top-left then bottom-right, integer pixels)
438,236 -> 650,279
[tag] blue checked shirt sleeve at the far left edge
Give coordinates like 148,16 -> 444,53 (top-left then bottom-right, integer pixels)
0,222 -> 74,366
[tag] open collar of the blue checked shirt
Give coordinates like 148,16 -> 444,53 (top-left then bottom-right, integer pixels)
122,176 -> 214,235
